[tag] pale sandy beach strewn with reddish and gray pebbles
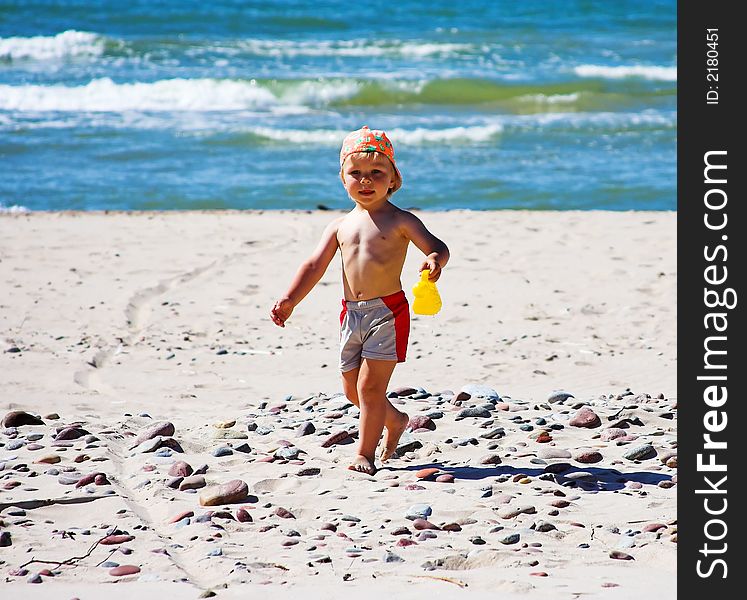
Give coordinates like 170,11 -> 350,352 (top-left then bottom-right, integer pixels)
0,210 -> 677,599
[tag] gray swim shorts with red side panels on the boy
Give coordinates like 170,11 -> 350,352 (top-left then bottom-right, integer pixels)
340,290 -> 410,373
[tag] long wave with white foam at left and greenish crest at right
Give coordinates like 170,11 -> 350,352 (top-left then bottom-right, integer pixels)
0,78 -> 612,113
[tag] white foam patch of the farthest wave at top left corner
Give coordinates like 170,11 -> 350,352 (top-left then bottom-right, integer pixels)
0,29 -> 104,60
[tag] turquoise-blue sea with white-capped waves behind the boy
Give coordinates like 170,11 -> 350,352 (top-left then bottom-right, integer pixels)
0,0 -> 677,211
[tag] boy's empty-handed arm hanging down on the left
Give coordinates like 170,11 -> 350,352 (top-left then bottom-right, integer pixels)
270,217 -> 343,327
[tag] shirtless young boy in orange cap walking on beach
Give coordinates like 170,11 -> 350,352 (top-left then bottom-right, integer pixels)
270,126 -> 449,475
